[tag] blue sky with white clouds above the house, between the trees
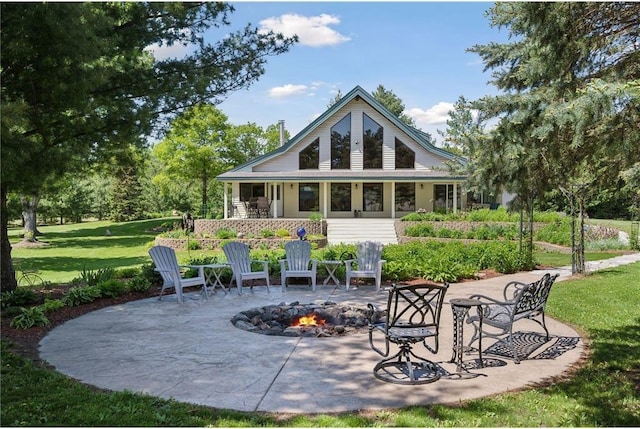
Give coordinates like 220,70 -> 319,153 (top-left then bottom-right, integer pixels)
150,1 -> 508,144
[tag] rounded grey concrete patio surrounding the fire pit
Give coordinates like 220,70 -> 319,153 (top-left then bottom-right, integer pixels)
40,257 -> 624,413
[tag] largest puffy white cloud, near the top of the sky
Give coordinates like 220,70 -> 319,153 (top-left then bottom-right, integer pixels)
260,13 -> 351,47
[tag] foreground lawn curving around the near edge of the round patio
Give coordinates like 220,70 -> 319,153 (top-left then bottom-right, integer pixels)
0,263 -> 640,427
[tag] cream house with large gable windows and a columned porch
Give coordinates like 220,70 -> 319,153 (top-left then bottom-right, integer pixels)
217,86 -> 504,219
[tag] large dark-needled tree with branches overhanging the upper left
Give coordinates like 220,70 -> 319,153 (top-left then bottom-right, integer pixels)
0,2 -> 296,291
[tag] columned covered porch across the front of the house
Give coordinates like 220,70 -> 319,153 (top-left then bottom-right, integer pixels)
223,177 -> 473,219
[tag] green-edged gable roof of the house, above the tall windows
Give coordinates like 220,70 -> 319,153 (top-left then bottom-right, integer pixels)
217,85 -> 466,180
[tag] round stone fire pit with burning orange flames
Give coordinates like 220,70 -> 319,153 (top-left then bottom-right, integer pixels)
231,301 -> 384,337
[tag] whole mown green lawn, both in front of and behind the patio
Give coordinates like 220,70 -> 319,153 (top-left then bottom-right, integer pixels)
1,220 -> 640,427
